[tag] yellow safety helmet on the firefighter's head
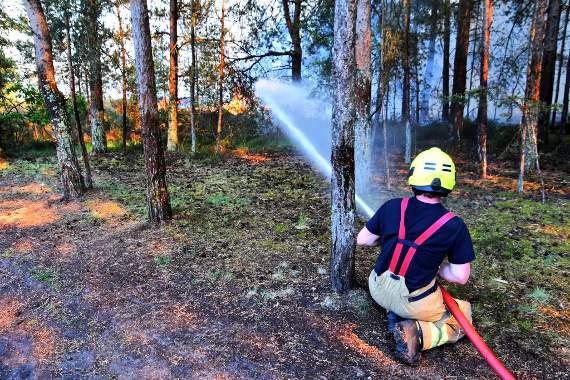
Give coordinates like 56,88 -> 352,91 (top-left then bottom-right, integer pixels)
408,147 -> 455,196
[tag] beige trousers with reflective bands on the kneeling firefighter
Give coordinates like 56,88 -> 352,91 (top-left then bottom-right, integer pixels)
368,270 -> 471,350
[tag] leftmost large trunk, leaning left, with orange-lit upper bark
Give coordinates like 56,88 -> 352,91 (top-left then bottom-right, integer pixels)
22,0 -> 85,199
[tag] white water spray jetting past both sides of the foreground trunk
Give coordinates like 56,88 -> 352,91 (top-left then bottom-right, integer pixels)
255,79 -> 379,217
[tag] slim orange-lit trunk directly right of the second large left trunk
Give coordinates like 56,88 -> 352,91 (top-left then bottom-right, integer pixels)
166,0 -> 178,151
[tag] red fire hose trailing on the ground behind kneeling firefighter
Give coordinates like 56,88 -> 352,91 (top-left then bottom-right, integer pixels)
440,285 -> 515,380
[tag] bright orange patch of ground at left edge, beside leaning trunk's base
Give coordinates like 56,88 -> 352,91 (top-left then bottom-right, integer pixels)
0,199 -> 58,228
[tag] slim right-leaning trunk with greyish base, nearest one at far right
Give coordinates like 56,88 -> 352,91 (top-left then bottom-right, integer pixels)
517,0 -> 546,193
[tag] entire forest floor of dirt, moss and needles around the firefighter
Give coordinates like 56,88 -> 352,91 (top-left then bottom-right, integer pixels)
0,147 -> 570,379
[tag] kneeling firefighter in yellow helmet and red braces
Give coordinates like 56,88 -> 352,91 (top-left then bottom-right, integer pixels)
357,148 -> 475,365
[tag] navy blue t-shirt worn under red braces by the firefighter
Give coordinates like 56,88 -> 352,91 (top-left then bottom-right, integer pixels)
366,197 -> 475,293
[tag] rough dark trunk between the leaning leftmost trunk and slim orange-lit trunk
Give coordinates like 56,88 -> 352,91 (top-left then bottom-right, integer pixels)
130,0 -> 172,223
